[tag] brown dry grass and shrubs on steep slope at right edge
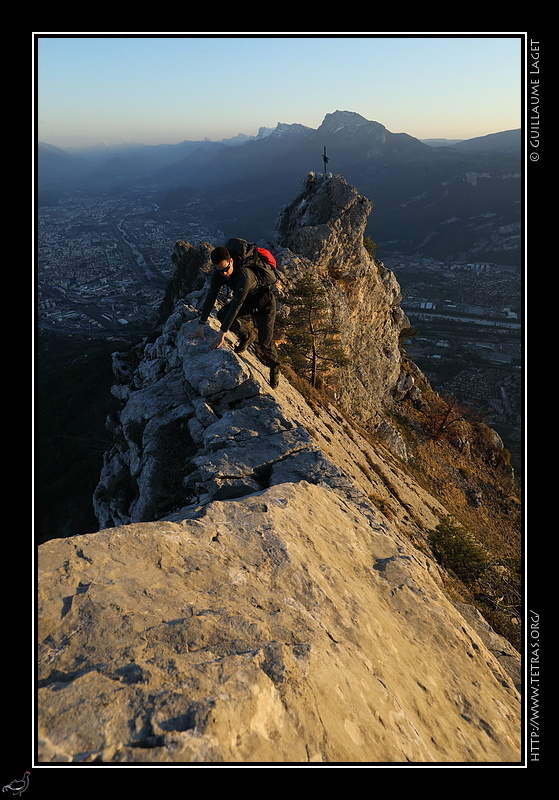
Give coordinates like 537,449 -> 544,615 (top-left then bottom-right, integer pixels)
400,386 -> 522,649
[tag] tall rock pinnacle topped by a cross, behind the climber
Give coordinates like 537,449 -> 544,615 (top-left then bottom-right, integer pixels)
278,173 -> 409,425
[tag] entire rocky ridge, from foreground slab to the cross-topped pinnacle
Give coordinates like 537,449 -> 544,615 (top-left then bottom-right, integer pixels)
38,176 -> 520,764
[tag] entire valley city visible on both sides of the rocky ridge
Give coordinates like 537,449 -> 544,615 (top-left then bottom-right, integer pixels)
37,191 -> 522,472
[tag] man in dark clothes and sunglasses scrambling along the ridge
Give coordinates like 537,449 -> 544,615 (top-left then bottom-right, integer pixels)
192,239 -> 280,388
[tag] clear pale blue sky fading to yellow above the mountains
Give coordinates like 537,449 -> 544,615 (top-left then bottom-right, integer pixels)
33,32 -> 523,148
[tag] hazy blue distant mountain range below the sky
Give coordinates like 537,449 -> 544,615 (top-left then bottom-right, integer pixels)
37,111 -> 522,265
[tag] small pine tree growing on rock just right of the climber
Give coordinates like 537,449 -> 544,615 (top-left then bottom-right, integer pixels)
280,272 -> 349,387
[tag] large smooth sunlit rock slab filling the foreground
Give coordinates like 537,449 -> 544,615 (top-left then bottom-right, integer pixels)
39,481 -> 520,764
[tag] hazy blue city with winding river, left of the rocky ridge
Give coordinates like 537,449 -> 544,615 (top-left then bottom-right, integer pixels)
37,193 -> 222,339
